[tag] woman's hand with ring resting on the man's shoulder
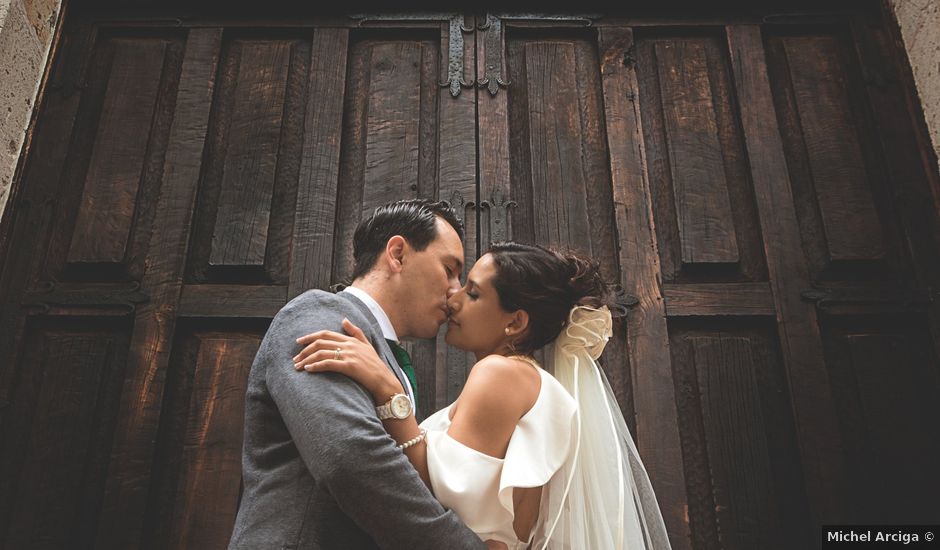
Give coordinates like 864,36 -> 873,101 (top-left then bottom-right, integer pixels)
294,319 -> 403,403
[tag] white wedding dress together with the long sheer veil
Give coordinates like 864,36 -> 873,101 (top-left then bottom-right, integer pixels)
421,305 -> 671,550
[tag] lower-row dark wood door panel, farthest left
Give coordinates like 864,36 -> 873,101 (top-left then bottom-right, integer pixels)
0,316 -> 131,548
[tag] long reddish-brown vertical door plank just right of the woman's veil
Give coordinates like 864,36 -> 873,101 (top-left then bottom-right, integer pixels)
599,27 -> 691,550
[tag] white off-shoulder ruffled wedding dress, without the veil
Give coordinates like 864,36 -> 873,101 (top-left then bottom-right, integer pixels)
421,366 -> 577,550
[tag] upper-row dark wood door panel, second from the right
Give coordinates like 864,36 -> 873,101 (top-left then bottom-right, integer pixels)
634,28 -> 767,283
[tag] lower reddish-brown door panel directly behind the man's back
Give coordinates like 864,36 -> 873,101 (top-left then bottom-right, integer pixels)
168,334 -> 261,549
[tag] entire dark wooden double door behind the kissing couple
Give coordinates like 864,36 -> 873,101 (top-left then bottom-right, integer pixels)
0,8 -> 940,550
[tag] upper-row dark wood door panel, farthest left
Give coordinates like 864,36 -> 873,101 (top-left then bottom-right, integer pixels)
40,29 -> 185,282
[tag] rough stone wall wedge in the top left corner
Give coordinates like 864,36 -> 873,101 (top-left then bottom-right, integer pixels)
0,0 -> 62,225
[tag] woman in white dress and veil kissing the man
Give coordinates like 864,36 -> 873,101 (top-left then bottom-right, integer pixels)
295,242 -> 670,550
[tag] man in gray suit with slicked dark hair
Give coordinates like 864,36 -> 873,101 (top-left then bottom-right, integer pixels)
229,200 -> 485,549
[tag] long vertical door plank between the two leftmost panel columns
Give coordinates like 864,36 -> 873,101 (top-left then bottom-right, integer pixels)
96,28 -> 222,548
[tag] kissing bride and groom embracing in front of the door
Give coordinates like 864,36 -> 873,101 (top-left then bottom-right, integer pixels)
229,200 -> 670,550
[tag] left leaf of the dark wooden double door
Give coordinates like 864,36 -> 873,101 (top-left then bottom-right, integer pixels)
0,15 -> 477,548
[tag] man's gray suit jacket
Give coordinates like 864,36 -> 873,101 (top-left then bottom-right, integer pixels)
229,290 -> 484,549
